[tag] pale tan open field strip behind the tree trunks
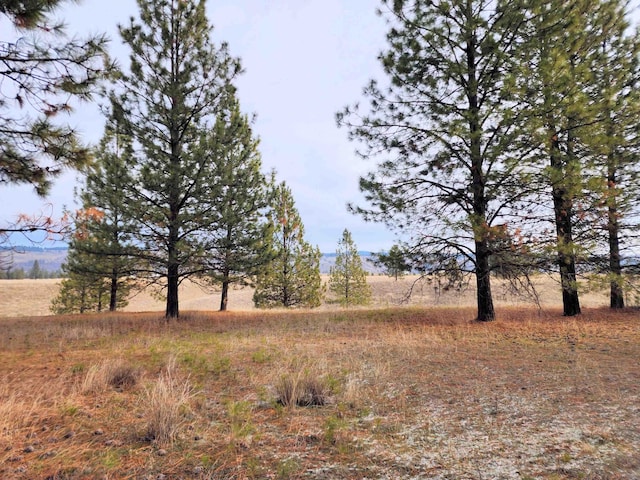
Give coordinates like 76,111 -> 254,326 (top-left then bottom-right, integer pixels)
0,275 -> 608,317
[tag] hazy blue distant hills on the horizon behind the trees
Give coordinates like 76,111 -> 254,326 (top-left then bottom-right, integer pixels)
0,246 -> 380,274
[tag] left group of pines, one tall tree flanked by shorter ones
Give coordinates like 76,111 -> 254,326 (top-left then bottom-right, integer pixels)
40,0 -> 376,318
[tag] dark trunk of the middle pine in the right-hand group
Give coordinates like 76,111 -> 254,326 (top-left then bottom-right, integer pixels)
550,133 -> 580,317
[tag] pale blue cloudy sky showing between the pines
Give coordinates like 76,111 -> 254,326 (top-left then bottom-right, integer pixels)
0,0 -> 395,253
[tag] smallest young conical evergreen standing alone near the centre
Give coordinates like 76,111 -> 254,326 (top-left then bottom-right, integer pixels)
329,229 -> 371,307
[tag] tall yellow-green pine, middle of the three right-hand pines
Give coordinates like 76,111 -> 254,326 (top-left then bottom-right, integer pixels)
512,0 -> 637,316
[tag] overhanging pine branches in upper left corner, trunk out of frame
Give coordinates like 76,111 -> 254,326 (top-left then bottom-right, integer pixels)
0,0 -> 107,196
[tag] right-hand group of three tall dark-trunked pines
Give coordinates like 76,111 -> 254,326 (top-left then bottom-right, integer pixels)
337,0 -> 640,321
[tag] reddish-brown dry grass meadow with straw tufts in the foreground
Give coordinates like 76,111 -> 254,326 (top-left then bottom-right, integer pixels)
0,277 -> 640,480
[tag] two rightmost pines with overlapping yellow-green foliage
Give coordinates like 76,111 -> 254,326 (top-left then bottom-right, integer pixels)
502,0 -> 640,315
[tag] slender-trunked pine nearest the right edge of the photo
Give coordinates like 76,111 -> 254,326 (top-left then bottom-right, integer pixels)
587,0 -> 640,308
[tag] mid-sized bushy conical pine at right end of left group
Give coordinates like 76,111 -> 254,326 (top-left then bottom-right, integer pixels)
253,182 -> 323,308
